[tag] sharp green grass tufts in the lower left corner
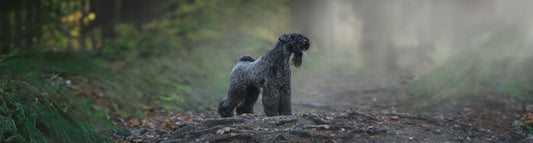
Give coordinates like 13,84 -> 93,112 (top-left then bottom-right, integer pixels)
0,53 -> 110,142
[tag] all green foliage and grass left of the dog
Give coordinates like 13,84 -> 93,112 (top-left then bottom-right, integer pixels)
0,0 -> 289,142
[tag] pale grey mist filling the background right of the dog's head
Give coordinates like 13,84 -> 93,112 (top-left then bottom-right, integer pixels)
274,0 -> 533,111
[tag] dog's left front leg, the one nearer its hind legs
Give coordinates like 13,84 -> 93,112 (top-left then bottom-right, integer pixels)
263,83 -> 280,116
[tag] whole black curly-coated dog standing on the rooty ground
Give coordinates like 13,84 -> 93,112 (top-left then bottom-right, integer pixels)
218,34 -> 310,117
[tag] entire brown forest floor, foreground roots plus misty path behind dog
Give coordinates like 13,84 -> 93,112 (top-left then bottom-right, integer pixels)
108,76 -> 533,143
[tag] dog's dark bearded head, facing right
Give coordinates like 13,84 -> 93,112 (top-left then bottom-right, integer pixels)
279,34 -> 310,67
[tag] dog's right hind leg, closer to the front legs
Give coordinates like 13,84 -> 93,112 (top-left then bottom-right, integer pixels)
237,86 -> 259,114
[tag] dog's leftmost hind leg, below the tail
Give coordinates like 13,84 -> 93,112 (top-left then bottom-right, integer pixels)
217,84 -> 246,117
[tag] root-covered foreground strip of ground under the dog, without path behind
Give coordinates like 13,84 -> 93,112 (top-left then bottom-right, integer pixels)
111,107 -> 533,142
